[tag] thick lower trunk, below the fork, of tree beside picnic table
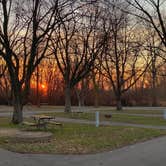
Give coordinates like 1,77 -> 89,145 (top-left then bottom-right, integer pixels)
12,92 -> 23,124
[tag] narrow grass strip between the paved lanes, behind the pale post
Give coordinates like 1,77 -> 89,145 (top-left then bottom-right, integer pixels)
42,112 -> 166,126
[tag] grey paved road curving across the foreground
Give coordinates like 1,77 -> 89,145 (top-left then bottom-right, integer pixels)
0,137 -> 166,166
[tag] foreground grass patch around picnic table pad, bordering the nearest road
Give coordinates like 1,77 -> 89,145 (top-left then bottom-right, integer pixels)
0,115 -> 166,154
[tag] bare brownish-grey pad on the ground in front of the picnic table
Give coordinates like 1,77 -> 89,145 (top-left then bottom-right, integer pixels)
0,128 -> 53,143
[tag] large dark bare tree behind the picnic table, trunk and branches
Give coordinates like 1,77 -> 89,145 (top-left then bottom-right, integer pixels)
0,0 -> 67,123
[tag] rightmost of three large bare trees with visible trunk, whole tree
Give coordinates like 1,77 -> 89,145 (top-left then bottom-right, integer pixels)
103,1 -> 147,110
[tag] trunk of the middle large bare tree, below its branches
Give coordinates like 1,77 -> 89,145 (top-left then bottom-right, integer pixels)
65,84 -> 71,112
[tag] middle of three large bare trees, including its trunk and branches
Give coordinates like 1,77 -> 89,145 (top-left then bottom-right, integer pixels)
52,1 -> 103,112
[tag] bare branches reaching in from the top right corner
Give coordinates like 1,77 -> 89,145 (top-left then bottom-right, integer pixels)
126,0 -> 166,46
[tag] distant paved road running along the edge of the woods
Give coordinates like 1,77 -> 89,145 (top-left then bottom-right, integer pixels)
0,106 -> 166,117
